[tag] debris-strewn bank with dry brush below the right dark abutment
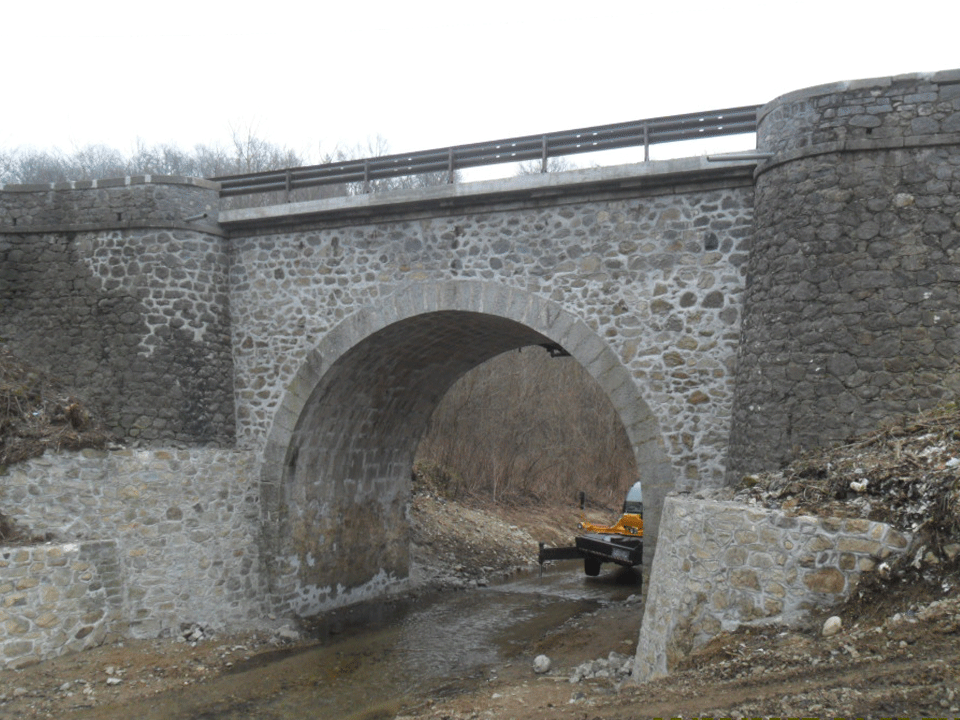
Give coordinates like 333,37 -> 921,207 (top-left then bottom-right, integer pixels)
734,403 -> 960,615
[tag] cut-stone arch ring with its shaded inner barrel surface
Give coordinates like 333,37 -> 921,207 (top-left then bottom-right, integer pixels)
260,280 -> 673,616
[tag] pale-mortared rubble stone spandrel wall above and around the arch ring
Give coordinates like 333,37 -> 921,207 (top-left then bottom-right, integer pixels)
226,174 -> 752,487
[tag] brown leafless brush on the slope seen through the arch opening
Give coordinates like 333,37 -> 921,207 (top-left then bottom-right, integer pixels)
417,348 -> 637,507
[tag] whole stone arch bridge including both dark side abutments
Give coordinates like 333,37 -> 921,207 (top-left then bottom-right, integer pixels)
0,67 -> 960,614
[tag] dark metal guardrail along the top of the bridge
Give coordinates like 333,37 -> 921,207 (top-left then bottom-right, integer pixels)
211,105 -> 760,196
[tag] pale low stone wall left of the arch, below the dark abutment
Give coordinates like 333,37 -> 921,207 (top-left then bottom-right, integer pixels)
0,448 -> 260,652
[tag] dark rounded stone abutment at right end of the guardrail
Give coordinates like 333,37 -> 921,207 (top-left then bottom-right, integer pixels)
728,71 -> 960,481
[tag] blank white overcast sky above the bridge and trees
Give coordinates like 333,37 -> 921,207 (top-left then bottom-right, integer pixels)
0,0 -> 960,173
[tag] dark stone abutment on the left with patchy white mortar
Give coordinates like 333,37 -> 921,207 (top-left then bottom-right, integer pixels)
0,178 -> 234,446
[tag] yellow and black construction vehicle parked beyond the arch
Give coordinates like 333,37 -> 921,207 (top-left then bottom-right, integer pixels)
538,480 -> 643,577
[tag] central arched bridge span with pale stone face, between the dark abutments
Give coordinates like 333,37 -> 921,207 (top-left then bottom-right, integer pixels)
220,160 -> 752,608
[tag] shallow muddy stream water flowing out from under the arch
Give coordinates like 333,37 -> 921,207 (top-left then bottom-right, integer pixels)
127,563 -> 640,720
